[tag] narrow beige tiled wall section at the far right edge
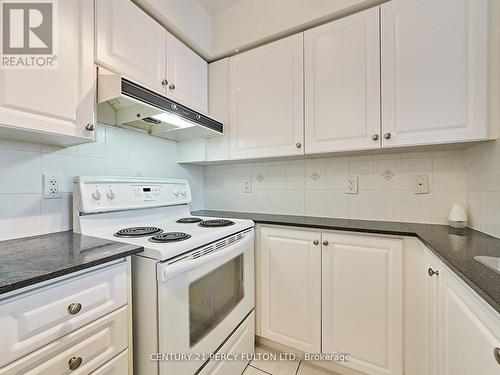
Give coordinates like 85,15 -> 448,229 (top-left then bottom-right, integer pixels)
465,139 -> 500,237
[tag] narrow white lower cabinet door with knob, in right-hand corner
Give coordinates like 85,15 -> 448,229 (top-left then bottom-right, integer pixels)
422,250 -> 442,375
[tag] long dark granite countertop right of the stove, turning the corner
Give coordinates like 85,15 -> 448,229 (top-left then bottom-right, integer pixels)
192,210 -> 500,313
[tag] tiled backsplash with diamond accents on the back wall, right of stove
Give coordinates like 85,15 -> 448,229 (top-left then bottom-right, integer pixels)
205,150 -> 466,224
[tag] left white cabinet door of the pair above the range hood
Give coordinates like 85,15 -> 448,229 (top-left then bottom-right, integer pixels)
95,0 -> 167,94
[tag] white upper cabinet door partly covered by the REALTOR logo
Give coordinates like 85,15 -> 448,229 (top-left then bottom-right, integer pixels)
0,0 -> 95,145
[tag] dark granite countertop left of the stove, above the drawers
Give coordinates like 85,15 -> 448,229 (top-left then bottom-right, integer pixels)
0,231 -> 143,294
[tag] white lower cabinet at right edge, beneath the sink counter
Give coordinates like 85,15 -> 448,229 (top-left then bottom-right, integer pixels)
424,250 -> 500,375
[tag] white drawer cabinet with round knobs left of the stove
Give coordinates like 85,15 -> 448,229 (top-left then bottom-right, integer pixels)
0,261 -> 131,375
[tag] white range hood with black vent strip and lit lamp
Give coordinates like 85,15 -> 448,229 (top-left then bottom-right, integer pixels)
97,68 -> 224,141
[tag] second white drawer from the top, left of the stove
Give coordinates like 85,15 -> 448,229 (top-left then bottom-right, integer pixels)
0,307 -> 128,375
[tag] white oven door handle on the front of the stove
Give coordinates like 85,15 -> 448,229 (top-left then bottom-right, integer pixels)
157,232 -> 254,282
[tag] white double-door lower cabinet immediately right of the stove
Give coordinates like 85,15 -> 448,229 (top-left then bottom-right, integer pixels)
258,226 -> 403,375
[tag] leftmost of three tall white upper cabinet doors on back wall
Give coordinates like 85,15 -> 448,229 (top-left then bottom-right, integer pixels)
229,34 -> 304,159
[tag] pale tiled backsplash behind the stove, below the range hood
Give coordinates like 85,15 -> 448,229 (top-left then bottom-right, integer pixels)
0,125 -> 204,240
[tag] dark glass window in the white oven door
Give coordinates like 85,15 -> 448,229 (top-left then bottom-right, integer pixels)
189,254 -> 244,347
